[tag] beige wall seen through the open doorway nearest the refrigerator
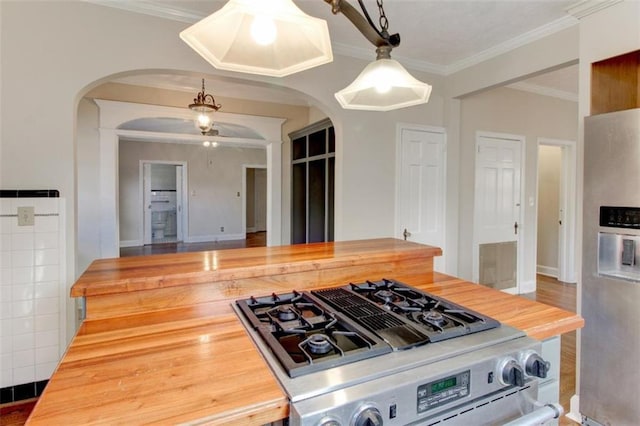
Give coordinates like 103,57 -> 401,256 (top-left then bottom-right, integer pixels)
537,145 -> 562,274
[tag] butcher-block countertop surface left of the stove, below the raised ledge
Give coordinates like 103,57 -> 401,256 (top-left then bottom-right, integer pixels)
27,315 -> 288,425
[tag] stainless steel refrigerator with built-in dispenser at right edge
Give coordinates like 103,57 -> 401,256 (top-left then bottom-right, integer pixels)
580,109 -> 640,425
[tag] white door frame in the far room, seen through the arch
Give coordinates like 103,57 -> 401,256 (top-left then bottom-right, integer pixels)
138,160 -> 189,244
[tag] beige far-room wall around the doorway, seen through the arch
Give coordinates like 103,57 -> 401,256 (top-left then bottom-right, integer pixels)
119,140 -> 266,242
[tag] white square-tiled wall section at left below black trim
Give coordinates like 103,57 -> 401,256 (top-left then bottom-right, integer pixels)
0,198 -> 67,388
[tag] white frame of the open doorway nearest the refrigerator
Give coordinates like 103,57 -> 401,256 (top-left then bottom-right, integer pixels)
535,138 -> 577,283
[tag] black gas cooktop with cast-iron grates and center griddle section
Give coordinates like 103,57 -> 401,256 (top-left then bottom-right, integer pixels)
236,279 -> 500,377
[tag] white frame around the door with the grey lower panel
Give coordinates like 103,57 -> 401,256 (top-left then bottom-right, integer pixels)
472,131 -> 526,294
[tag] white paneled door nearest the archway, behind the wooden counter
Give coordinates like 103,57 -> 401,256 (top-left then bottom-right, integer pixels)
396,127 -> 446,271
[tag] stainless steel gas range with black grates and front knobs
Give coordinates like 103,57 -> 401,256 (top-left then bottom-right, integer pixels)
234,280 -> 562,426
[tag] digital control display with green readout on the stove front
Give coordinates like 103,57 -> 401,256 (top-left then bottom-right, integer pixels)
417,370 -> 471,414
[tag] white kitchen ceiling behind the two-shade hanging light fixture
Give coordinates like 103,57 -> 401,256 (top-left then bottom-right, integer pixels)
127,0 -> 577,74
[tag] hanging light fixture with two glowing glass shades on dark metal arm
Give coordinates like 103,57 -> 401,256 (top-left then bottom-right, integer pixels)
180,0 -> 431,111
